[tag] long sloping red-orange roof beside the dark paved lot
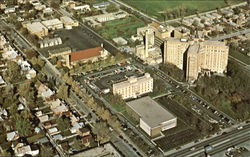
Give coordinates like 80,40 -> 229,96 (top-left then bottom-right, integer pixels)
70,47 -> 102,62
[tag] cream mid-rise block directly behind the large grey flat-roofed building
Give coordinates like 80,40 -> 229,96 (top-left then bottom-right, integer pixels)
113,73 -> 153,99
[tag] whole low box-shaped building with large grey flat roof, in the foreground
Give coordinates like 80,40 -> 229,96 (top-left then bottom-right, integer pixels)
126,96 -> 177,137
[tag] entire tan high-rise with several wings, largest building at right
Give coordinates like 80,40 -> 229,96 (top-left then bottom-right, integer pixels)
164,39 -> 229,82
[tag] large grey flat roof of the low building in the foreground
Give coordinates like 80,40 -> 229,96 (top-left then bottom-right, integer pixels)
127,96 -> 176,128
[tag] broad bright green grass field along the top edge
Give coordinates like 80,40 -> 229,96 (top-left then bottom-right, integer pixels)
123,0 -> 242,21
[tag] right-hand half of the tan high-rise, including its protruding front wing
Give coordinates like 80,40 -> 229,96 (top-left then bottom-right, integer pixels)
186,41 -> 229,82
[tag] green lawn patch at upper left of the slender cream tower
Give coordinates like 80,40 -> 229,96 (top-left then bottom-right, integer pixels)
96,16 -> 145,40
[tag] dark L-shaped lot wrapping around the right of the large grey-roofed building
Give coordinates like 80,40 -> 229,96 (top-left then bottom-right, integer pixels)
154,97 -> 208,151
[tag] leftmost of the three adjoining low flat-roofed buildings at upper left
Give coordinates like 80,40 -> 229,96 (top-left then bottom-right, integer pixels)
26,22 -> 48,38
